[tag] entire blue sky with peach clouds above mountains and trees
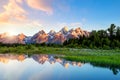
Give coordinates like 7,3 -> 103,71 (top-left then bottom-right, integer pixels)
0,0 -> 120,36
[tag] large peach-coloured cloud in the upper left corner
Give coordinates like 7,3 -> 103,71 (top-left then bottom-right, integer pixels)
0,0 -> 27,23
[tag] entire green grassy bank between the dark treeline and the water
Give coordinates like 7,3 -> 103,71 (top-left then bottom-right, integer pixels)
0,46 -> 120,67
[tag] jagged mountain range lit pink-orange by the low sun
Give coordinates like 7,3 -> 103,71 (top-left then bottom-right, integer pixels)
0,27 -> 90,44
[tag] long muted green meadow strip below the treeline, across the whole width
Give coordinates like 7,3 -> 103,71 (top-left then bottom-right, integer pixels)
0,45 -> 120,56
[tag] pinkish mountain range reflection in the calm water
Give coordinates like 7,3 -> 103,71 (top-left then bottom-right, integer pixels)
0,54 -> 83,68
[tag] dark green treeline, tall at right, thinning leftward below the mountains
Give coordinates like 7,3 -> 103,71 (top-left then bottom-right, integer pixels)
0,24 -> 120,49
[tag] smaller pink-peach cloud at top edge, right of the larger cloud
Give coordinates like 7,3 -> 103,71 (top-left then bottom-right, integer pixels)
26,0 -> 53,14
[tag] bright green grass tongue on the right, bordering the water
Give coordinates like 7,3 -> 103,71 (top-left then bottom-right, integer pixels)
64,56 -> 120,67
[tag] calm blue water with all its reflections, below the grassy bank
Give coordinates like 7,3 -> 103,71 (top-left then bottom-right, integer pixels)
0,54 -> 120,80
